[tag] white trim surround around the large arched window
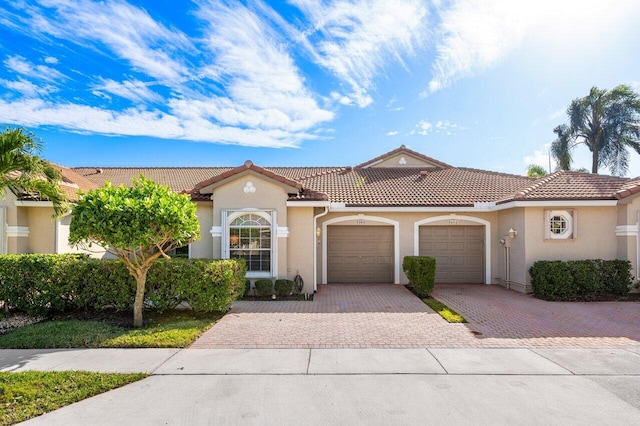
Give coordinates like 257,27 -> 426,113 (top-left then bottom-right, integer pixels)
221,208 -> 278,278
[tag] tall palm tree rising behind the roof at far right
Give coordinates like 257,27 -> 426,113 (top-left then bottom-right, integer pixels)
551,84 -> 640,176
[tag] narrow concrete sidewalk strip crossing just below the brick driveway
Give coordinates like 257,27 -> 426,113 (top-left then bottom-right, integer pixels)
0,345 -> 640,381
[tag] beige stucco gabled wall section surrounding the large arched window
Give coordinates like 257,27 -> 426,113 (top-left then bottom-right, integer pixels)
208,171 -> 296,278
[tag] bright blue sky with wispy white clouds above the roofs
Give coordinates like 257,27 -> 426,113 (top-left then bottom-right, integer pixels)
0,0 -> 640,176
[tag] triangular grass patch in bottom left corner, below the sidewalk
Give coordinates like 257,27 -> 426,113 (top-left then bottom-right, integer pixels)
0,371 -> 147,425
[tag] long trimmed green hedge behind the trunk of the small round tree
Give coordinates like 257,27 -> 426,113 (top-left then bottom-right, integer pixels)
0,254 -> 246,315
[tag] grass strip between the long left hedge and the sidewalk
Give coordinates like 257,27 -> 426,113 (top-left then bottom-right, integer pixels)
0,312 -> 223,349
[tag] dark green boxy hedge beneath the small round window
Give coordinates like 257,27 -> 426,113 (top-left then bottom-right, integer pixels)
529,259 -> 633,300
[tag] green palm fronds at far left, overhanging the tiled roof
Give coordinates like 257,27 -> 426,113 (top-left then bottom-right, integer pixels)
0,128 -> 67,217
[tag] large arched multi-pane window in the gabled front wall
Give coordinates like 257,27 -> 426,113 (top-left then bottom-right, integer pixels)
229,213 -> 271,272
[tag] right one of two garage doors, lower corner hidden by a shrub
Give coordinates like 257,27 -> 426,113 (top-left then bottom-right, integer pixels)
419,226 -> 484,283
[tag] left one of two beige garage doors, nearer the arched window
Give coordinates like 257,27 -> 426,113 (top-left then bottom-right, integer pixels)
327,226 -> 394,283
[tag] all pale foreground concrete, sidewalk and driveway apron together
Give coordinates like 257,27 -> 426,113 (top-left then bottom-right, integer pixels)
0,346 -> 640,425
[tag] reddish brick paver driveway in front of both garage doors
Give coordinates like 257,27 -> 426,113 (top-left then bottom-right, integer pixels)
191,284 -> 640,348
